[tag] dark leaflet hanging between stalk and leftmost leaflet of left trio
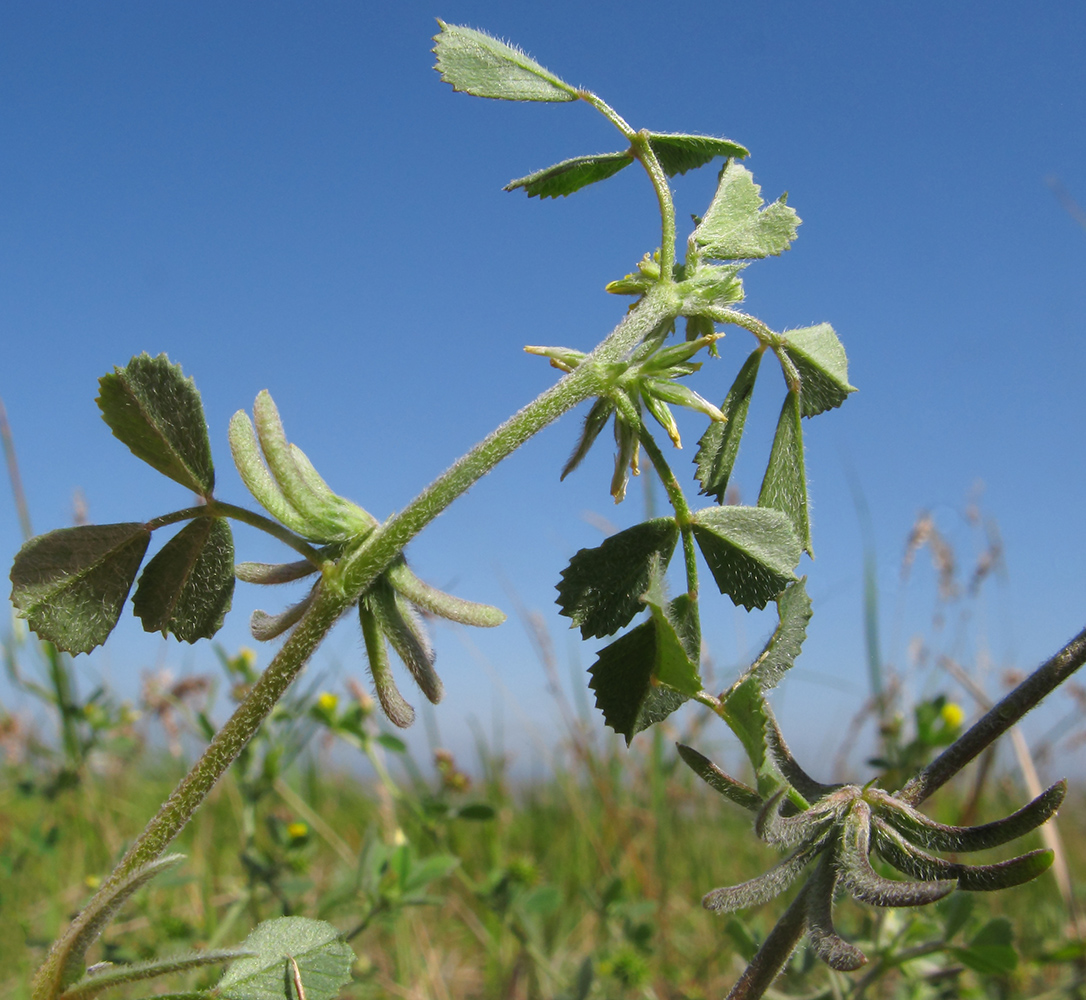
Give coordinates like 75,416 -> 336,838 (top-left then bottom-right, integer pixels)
132,517 -> 233,643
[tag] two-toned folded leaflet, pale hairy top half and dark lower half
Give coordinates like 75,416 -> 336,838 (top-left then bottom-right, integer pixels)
693,506 -> 801,610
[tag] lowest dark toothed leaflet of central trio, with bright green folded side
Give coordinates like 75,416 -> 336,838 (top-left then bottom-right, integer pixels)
589,602 -> 696,746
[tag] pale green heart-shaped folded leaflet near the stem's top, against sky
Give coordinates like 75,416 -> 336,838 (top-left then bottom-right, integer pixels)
694,160 -> 799,261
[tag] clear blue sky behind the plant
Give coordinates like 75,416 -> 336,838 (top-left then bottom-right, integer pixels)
0,0 -> 1086,773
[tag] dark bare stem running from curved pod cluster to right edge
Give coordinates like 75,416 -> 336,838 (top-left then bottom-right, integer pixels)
897,629 -> 1086,806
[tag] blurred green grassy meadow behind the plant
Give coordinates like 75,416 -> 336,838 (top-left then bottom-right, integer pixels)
0,707 -> 1086,1000
